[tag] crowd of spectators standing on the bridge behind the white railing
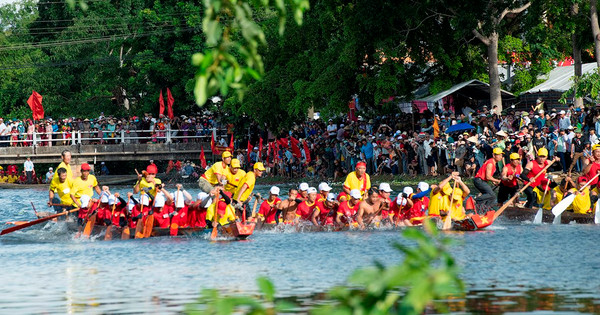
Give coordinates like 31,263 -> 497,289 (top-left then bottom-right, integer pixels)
0,113 -> 220,147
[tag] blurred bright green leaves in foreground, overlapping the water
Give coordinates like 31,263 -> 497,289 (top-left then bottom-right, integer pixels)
186,220 -> 464,315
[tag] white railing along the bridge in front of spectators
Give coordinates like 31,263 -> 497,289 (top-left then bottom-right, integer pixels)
0,128 -> 229,147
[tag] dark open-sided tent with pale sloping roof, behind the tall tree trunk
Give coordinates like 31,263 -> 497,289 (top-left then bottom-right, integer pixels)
413,80 -> 515,112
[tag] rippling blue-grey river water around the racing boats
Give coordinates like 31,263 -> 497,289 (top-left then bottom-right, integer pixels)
0,186 -> 600,314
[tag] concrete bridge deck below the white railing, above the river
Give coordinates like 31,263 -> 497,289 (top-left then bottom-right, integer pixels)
0,142 -> 215,165
